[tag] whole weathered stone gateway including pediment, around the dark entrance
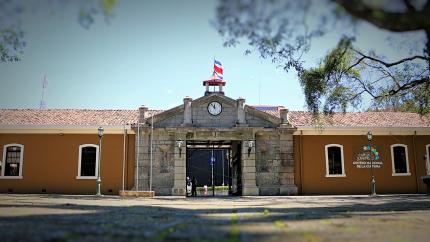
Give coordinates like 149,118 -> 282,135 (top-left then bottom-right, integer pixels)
136,95 -> 297,195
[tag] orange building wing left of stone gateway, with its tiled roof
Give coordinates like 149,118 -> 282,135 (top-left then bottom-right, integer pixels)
0,109 -> 137,194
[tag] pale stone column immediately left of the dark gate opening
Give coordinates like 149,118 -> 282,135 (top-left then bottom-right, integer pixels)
172,133 -> 187,196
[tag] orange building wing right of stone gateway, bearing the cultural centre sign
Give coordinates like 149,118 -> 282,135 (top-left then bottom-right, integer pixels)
292,112 -> 430,194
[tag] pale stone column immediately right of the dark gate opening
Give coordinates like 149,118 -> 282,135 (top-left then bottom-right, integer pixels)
242,140 -> 258,196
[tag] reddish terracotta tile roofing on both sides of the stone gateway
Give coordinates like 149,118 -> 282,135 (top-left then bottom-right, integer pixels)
0,106 -> 430,127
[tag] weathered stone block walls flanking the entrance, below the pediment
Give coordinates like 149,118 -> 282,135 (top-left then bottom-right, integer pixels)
136,127 -> 297,195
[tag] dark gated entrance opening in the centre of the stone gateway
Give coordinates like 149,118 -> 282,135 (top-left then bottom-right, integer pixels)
186,141 -> 242,197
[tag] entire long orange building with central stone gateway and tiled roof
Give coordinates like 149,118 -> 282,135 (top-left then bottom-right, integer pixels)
0,83 -> 430,196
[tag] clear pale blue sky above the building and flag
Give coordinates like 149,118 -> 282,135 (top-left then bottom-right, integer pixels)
0,0 -> 424,110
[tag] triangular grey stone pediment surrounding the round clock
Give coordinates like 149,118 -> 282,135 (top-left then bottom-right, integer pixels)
146,94 -> 281,128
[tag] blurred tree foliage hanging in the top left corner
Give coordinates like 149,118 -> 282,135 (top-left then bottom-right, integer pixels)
0,0 -> 117,63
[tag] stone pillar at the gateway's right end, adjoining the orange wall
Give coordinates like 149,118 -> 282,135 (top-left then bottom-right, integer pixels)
279,129 -> 297,195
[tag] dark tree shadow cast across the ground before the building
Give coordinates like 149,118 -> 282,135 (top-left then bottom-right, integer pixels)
0,195 -> 430,241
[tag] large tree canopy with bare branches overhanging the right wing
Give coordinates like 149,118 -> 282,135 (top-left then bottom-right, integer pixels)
214,0 -> 430,114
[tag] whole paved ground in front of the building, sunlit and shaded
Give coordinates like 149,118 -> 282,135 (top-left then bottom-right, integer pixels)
0,194 -> 430,242
